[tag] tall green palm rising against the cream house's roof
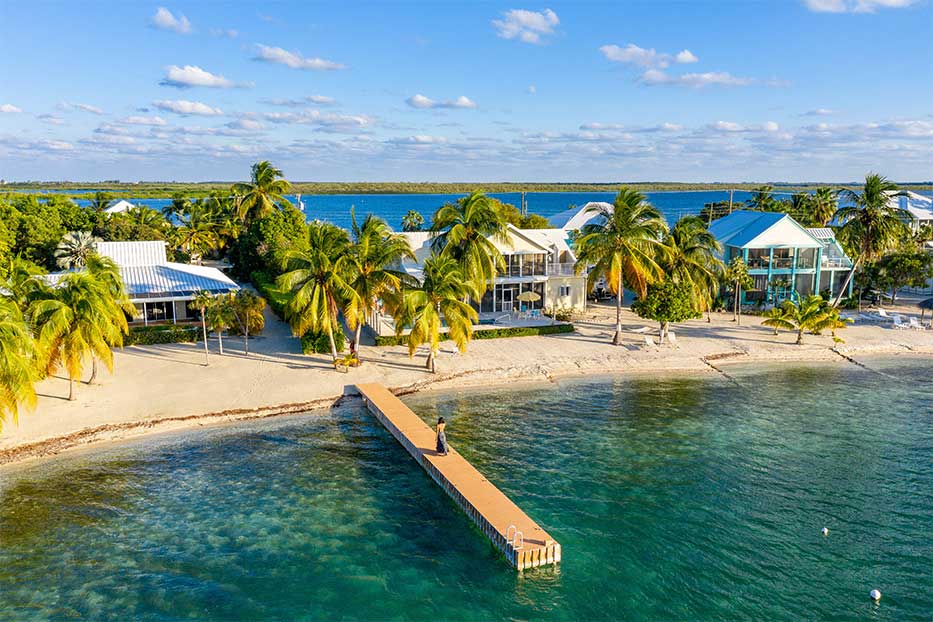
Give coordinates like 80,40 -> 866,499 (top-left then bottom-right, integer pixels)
430,190 -> 509,299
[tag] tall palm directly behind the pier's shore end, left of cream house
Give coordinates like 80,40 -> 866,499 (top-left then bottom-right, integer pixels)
346,210 -> 417,352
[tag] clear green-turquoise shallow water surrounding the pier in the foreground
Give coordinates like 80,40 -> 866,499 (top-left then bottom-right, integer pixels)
0,361 -> 933,620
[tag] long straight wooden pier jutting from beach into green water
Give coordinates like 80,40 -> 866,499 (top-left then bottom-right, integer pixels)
356,383 -> 561,570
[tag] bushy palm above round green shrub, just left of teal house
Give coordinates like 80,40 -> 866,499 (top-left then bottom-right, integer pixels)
662,216 -> 725,322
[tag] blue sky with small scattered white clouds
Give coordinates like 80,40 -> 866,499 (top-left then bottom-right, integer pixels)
0,0 -> 933,182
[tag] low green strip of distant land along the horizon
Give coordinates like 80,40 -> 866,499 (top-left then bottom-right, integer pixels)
0,181 -> 933,199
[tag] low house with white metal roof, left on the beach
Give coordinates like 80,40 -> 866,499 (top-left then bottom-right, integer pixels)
48,240 -> 240,325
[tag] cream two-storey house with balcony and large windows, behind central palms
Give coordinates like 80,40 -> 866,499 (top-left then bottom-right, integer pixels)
402,225 -> 586,316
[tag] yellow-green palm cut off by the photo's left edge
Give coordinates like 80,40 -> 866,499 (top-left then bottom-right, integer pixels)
0,296 -> 38,431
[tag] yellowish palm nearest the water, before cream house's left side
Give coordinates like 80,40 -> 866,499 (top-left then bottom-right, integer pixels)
395,254 -> 479,374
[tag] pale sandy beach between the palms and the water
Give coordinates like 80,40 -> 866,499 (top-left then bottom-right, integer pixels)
0,305 -> 933,464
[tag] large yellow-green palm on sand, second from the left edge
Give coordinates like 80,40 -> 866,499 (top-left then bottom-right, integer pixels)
32,272 -> 129,400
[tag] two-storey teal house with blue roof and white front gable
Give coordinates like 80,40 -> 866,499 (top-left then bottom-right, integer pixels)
709,210 -> 852,304
